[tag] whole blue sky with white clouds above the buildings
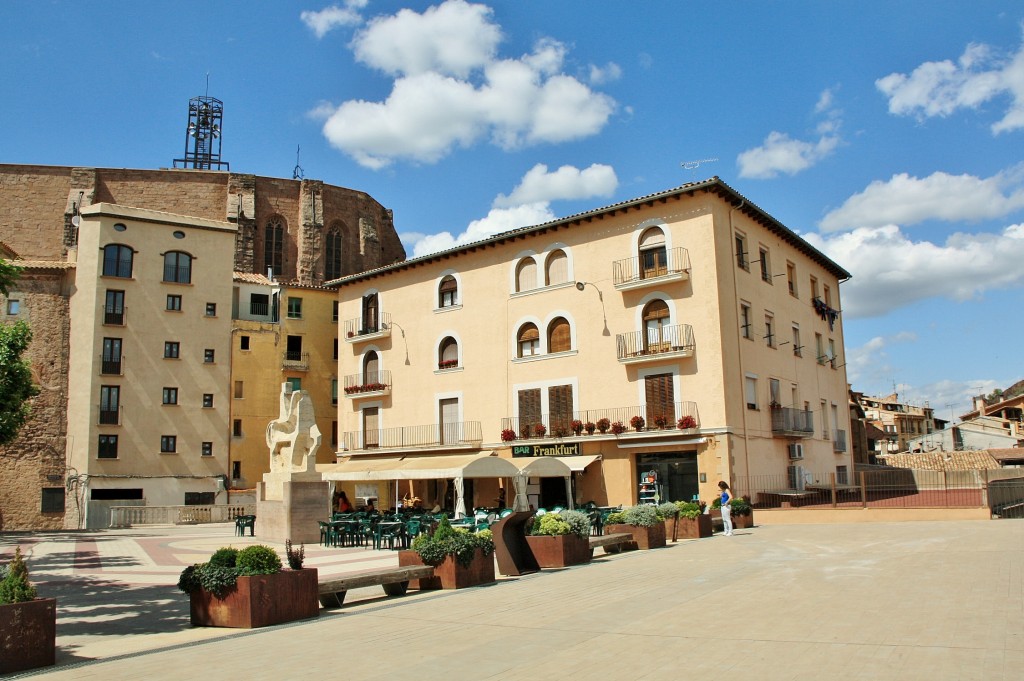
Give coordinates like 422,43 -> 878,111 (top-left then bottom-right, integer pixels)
0,0 -> 1024,418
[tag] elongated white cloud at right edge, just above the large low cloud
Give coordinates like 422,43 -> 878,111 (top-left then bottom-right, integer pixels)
819,165 -> 1024,231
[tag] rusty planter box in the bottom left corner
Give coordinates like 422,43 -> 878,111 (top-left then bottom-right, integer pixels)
0,598 -> 57,674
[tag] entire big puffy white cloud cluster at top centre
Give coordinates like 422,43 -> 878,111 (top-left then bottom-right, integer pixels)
316,0 -> 615,169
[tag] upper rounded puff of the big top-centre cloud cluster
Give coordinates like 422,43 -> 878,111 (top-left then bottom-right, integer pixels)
352,0 -> 502,78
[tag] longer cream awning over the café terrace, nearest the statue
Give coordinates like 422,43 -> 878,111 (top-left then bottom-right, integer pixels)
316,453 -> 519,480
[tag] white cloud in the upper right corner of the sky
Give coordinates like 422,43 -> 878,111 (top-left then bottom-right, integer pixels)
874,37 -> 1024,134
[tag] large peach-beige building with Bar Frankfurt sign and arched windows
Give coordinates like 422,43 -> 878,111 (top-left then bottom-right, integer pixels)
329,178 -> 852,508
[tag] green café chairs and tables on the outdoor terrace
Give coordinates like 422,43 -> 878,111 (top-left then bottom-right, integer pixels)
319,503 -> 622,550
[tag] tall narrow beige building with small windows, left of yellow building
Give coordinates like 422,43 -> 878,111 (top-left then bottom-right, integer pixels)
68,203 -> 236,526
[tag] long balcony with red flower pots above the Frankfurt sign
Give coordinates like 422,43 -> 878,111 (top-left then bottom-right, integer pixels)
501,401 -> 700,442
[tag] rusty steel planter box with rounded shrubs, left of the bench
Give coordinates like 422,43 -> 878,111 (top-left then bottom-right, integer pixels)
189,568 -> 319,629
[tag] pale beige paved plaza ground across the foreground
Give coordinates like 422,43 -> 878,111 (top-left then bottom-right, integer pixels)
0,520 -> 1024,681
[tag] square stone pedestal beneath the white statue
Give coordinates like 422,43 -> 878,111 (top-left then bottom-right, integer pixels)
256,480 -> 331,544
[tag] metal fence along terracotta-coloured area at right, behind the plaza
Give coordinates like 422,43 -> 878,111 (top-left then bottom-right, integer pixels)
733,466 -> 1024,509
